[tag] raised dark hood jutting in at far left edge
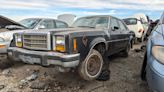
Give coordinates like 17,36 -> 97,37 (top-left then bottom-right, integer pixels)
0,15 -> 24,28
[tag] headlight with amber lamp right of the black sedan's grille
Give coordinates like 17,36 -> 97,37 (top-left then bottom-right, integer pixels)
53,36 -> 65,52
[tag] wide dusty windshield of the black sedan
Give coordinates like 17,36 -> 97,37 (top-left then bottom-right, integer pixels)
72,16 -> 109,28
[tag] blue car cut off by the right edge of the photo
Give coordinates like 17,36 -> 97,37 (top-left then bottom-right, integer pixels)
141,13 -> 164,92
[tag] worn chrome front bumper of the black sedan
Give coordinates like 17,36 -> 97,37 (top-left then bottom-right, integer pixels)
8,47 -> 80,68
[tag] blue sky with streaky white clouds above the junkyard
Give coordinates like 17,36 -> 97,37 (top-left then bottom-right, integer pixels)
0,0 -> 164,21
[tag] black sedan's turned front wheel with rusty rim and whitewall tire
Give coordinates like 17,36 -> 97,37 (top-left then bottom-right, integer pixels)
78,49 -> 104,80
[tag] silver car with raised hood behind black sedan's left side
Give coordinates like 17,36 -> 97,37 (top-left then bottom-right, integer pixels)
0,17 -> 68,54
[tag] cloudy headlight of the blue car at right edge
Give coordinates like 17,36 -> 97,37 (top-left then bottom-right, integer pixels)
152,46 -> 164,64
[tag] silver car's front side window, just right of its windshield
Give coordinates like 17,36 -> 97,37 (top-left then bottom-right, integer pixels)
40,20 -> 56,29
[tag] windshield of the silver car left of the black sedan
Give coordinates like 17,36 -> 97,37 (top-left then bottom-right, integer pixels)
19,19 -> 40,29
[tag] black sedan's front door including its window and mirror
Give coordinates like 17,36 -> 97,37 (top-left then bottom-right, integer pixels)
108,17 -> 121,53
